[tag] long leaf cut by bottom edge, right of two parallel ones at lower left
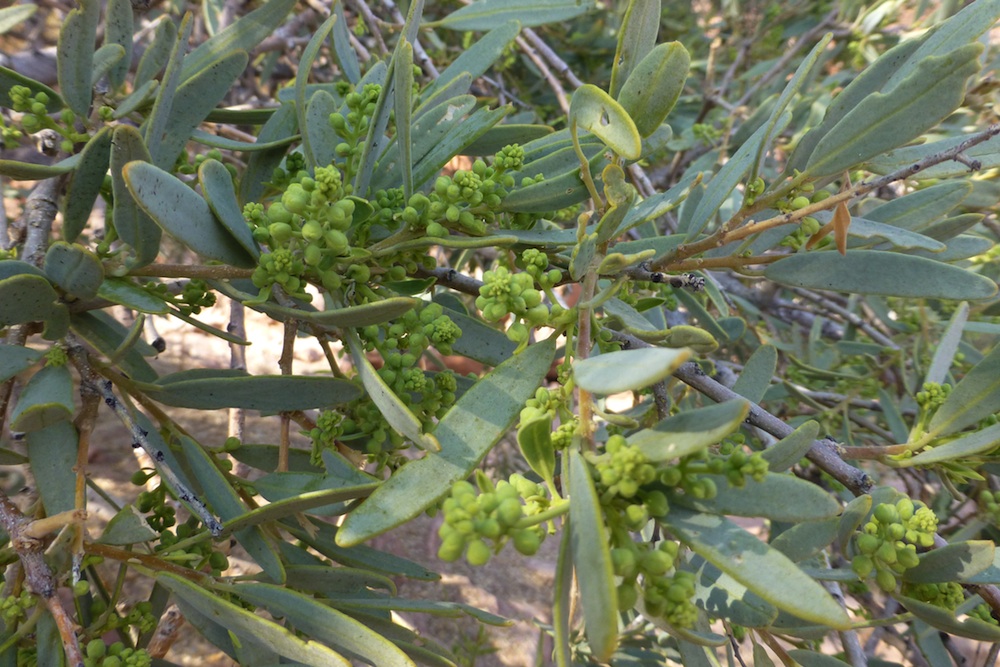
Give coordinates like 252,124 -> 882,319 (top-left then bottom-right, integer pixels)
234,583 -> 415,667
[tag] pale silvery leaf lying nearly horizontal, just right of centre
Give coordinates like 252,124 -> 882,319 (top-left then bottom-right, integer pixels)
573,347 -> 691,395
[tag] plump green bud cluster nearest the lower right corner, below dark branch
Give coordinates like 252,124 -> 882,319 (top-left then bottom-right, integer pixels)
851,497 -> 937,592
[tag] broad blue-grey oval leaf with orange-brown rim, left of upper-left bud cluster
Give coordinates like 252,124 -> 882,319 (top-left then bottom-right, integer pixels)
124,161 -> 256,268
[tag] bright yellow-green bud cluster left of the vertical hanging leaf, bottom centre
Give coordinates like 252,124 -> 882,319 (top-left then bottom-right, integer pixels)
438,474 -> 549,565
